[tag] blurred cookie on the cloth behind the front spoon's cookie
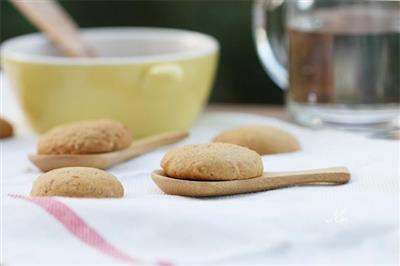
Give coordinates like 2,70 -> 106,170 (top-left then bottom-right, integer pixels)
213,125 -> 300,155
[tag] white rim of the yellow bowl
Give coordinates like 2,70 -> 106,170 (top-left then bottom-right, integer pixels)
0,27 -> 219,65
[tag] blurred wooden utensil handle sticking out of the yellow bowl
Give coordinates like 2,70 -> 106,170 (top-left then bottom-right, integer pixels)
11,0 -> 94,57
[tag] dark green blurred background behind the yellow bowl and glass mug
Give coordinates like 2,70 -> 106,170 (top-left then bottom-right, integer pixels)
0,0 -> 283,104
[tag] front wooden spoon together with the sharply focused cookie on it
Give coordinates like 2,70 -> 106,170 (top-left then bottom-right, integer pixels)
152,143 -> 350,197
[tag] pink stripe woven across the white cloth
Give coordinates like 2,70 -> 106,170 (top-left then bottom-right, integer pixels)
9,194 -> 172,266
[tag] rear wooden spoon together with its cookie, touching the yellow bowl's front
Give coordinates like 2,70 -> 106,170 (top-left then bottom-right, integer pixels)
29,120 -> 188,171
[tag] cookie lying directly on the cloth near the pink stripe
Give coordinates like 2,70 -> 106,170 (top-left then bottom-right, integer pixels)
31,167 -> 124,198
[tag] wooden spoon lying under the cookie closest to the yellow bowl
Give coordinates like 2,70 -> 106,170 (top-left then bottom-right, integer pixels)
28,132 -> 189,172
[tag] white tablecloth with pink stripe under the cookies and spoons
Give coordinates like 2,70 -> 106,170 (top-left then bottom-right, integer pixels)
1,75 -> 400,265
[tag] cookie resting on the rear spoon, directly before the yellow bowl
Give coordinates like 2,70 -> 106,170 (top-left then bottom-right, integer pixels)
37,119 -> 132,154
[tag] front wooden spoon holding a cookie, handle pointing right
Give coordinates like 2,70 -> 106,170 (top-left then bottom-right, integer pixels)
152,167 -> 350,197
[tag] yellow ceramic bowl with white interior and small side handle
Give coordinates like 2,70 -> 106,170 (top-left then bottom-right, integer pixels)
1,28 -> 219,138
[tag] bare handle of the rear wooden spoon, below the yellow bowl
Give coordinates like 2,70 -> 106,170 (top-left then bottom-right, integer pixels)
114,131 -> 189,162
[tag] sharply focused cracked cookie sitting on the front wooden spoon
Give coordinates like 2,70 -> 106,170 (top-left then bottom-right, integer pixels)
161,143 -> 263,180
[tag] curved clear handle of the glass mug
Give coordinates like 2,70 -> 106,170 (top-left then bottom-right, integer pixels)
253,0 -> 288,90
